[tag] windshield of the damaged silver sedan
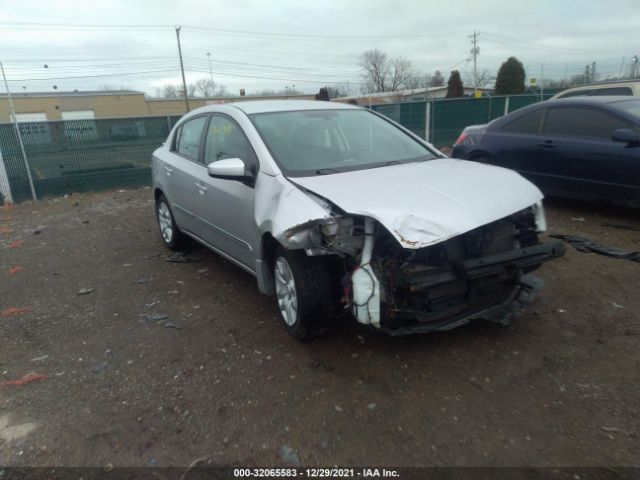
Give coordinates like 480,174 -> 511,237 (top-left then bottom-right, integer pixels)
251,109 -> 436,176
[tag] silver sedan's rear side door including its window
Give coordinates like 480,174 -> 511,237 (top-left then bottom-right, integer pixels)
160,115 -> 207,234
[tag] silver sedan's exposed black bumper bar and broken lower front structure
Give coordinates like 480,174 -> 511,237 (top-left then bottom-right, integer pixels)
381,241 -> 565,335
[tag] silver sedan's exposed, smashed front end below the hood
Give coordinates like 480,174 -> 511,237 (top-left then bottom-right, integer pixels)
289,205 -> 565,335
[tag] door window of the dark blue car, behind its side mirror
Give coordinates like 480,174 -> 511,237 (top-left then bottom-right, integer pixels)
542,107 -> 631,139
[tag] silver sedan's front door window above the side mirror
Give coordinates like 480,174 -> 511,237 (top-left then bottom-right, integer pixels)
204,116 -> 255,165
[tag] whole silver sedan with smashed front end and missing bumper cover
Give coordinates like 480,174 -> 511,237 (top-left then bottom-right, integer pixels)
153,100 -> 564,339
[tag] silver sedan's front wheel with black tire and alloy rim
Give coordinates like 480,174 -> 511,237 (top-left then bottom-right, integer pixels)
273,248 -> 333,340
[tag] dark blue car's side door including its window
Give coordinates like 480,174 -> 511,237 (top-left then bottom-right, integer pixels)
536,106 -> 639,201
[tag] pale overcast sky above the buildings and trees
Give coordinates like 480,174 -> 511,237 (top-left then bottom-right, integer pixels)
0,0 -> 640,94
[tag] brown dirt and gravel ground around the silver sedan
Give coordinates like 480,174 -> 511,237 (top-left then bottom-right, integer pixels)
0,190 -> 640,466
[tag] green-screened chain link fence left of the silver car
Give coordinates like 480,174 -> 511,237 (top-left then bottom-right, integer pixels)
0,116 -> 180,202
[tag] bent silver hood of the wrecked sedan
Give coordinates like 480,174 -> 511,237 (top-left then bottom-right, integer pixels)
289,158 -> 543,249
